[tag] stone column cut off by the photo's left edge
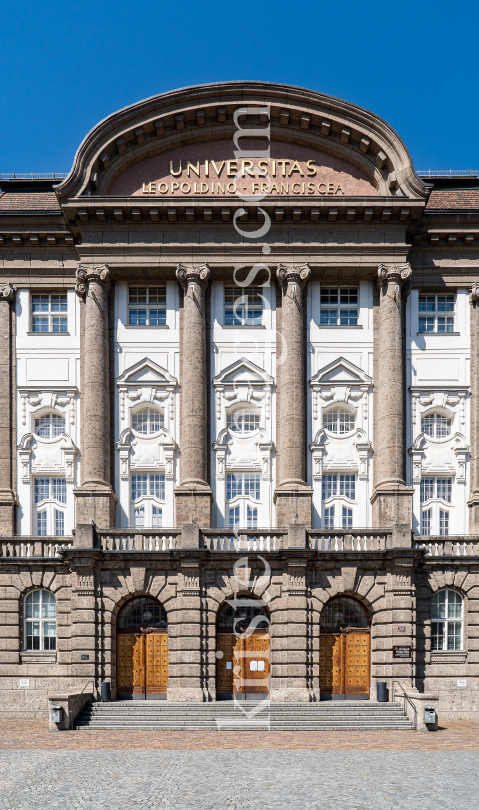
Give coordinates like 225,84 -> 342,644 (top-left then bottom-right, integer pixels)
0,284 -> 17,536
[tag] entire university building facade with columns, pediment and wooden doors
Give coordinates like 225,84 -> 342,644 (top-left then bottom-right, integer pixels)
0,82 -> 479,718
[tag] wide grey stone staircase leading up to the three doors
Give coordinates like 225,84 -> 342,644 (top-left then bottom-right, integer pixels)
75,700 -> 413,731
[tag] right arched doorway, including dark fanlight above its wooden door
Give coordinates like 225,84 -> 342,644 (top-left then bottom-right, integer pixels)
319,596 -> 371,700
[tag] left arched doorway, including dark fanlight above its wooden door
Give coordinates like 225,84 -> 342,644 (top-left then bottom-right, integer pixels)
116,596 -> 168,700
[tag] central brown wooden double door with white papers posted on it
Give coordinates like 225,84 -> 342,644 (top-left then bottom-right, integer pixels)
216,632 -> 270,697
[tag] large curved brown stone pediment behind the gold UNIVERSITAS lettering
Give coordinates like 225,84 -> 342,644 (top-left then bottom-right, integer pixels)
56,81 -> 427,204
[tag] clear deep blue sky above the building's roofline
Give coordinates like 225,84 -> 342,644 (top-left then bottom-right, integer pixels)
0,0 -> 479,172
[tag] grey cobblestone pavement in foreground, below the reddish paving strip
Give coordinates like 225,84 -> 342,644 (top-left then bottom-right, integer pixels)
0,749 -> 479,810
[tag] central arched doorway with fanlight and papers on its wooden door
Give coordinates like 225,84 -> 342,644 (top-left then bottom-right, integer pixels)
216,597 -> 270,700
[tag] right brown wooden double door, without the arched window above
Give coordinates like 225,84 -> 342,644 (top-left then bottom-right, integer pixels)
319,630 -> 370,697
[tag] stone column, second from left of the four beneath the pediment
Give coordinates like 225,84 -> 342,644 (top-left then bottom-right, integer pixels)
175,264 -> 212,527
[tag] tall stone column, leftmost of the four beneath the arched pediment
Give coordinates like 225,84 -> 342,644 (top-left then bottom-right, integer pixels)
75,264 -> 117,528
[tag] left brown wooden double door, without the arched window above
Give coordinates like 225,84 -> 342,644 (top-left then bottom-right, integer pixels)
116,633 -> 168,699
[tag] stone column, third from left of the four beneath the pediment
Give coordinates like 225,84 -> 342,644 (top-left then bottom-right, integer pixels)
274,264 -> 313,526
